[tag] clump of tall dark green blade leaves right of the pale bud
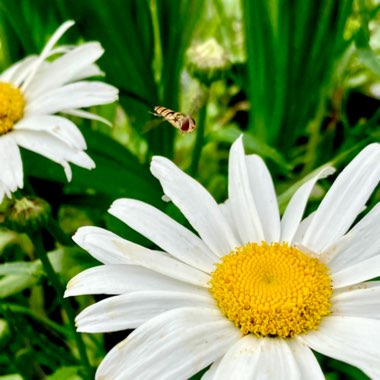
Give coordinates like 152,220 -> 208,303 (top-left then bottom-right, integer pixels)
243,0 -> 352,151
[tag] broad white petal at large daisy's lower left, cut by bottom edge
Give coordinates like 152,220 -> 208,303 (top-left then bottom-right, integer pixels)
96,308 -> 240,380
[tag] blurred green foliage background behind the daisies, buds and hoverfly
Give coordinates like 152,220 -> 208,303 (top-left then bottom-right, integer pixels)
0,0 -> 380,380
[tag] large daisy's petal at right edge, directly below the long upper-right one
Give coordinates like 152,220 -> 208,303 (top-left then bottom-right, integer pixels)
323,203 -> 380,272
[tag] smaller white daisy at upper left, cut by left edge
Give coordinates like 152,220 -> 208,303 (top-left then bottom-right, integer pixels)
0,21 -> 117,203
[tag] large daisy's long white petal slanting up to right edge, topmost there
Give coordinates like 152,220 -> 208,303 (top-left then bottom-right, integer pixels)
301,144 -> 380,252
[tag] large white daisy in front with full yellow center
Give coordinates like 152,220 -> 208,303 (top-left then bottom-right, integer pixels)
66,138 -> 380,380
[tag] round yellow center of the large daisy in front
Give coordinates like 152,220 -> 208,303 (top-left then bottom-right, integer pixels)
210,243 -> 332,338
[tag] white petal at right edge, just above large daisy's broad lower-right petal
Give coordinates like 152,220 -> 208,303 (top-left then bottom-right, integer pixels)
331,281 -> 380,319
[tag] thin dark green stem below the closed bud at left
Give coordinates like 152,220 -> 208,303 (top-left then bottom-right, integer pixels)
30,232 -> 92,379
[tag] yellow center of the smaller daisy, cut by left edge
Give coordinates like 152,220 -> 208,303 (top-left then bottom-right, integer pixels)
0,82 -> 25,135
